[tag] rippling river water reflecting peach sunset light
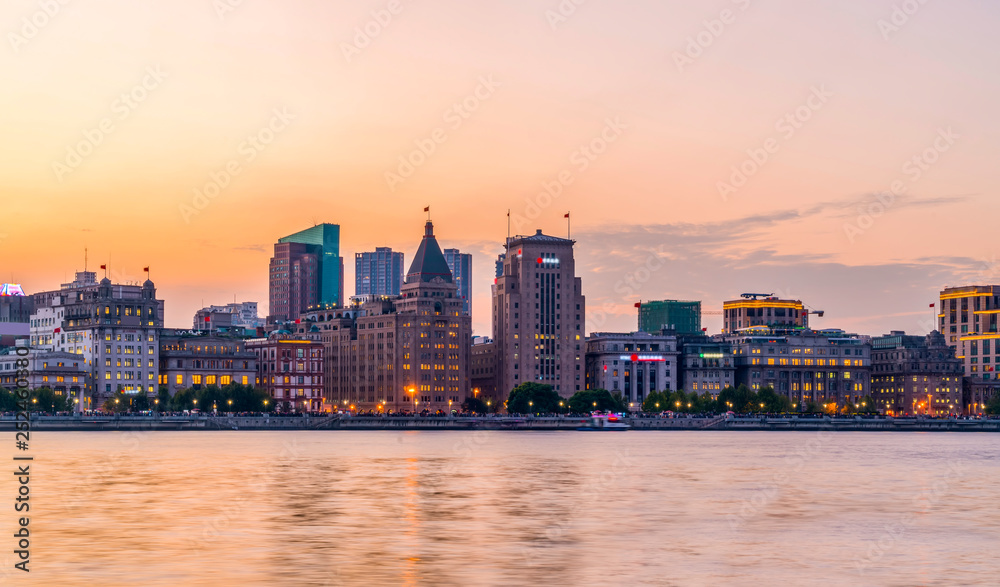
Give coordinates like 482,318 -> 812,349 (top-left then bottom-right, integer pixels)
0,431 -> 1000,587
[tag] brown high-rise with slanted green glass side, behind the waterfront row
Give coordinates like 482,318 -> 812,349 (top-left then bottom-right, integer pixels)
268,224 -> 344,322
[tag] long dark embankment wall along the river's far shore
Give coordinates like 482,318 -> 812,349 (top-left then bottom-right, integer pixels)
0,415 -> 1000,432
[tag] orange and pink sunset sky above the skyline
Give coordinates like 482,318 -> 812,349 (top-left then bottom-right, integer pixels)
0,0 -> 1000,335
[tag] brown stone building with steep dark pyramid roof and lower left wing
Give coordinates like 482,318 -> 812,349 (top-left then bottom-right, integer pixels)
293,222 -> 473,412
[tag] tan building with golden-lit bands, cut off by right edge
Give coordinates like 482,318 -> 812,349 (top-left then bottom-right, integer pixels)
938,285 -> 1000,384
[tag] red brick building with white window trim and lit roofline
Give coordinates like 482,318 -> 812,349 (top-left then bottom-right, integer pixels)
241,331 -> 323,412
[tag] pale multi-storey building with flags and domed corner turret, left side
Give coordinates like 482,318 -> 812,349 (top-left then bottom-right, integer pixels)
31,273 -> 163,410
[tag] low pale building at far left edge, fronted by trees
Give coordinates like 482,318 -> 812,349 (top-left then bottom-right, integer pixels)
0,348 -> 90,405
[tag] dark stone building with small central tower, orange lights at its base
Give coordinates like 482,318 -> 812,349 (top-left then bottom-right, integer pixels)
872,330 -> 964,416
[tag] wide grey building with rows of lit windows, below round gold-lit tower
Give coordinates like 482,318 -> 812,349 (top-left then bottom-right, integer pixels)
718,327 -> 871,409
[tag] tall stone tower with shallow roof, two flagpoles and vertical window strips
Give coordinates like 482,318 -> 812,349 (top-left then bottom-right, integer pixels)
493,230 -> 586,398
